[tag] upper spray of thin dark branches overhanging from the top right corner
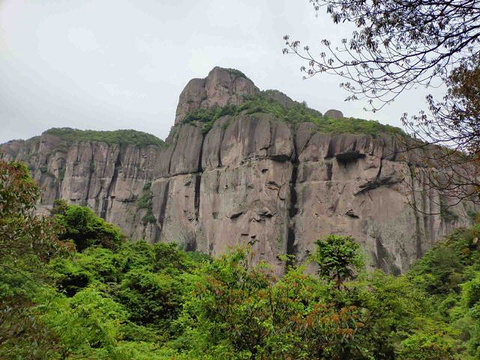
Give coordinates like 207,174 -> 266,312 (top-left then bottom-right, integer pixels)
284,0 -> 480,110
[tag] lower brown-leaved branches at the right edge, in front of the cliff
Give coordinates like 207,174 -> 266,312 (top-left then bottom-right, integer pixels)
403,56 -> 480,205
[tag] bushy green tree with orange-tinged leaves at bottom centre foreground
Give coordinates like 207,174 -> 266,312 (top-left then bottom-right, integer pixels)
175,250 -> 367,360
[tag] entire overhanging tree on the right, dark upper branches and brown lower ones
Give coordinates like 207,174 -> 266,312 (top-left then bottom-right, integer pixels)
284,0 -> 480,207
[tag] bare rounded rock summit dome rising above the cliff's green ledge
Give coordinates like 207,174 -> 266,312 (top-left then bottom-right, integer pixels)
175,66 -> 260,124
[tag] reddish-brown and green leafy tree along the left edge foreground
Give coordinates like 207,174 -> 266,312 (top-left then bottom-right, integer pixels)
0,161 -> 68,359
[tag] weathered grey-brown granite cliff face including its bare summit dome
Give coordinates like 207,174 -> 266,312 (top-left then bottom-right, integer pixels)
0,68 -> 471,272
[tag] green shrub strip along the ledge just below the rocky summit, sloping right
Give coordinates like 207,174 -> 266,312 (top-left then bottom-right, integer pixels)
183,90 -> 404,137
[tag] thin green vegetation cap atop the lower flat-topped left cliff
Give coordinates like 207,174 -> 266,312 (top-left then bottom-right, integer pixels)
44,128 -> 165,146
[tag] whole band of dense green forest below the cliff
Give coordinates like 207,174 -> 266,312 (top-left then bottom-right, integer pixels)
0,162 -> 480,360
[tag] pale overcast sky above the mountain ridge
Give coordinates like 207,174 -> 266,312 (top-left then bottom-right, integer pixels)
0,0 -> 442,143
